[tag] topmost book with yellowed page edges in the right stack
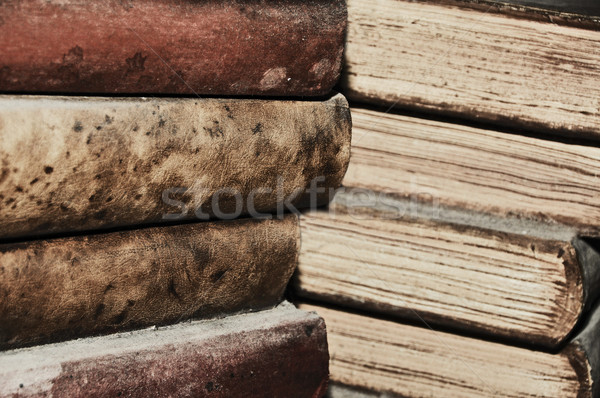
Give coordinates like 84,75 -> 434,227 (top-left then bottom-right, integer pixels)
342,0 -> 600,140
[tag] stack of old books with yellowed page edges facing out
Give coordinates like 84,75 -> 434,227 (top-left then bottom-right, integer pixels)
294,0 -> 600,397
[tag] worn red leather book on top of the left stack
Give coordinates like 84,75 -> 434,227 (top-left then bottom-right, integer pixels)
0,0 -> 346,96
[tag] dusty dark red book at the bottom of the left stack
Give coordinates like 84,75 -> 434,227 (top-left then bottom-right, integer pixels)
0,304 -> 329,397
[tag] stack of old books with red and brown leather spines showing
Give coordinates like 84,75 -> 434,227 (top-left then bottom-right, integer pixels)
0,0 -> 350,397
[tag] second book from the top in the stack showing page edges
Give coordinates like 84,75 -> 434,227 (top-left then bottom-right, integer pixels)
343,108 -> 600,237
